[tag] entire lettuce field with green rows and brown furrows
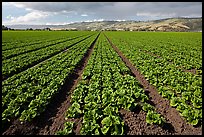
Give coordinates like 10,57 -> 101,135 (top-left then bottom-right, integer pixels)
2,31 -> 202,135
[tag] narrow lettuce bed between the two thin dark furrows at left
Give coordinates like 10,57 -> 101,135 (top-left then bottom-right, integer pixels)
2,34 -> 94,77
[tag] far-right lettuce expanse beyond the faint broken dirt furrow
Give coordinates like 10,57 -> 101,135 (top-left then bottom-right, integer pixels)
107,32 -> 202,73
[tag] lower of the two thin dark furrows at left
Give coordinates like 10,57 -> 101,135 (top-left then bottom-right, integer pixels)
2,34 -> 94,81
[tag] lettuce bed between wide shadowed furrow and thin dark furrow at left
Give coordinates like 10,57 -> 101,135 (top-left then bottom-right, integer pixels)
2,32 -> 99,125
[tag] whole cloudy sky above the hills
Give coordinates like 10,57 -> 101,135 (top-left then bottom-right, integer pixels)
2,2 -> 202,25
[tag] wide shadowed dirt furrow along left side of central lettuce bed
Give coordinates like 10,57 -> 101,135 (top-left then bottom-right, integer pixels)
3,33 -> 100,135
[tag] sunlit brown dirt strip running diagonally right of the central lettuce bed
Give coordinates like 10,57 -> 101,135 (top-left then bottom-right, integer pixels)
105,35 -> 202,135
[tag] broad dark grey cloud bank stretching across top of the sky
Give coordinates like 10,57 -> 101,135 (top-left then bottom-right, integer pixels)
7,2 -> 202,19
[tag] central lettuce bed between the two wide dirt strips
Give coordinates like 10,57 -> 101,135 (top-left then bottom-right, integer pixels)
56,35 -> 165,135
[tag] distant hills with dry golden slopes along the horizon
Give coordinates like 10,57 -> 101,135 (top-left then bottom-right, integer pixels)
5,17 -> 202,31
